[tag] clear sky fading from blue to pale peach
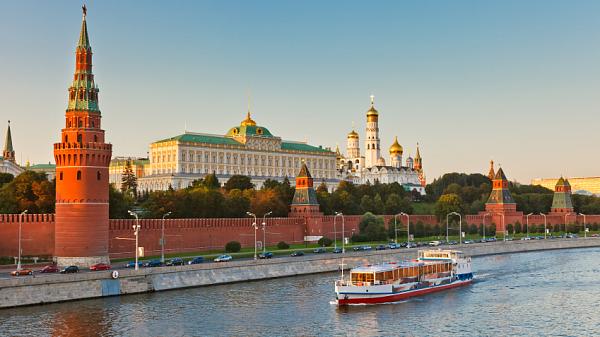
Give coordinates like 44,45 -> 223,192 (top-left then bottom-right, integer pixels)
0,0 -> 600,183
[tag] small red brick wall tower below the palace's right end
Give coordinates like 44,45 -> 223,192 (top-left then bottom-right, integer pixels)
289,163 -> 323,218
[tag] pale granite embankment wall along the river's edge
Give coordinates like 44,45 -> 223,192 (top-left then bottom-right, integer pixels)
0,238 -> 600,308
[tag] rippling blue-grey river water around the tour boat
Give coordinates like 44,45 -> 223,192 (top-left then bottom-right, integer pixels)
0,249 -> 600,336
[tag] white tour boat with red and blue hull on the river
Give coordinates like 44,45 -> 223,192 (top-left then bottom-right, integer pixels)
335,249 -> 473,306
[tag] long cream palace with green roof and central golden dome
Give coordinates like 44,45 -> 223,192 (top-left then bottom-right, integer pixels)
138,112 -> 340,191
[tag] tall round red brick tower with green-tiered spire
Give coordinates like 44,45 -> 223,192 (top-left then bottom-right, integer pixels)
54,6 -> 112,266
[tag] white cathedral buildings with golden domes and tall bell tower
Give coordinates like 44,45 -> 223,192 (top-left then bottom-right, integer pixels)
336,96 -> 426,195
